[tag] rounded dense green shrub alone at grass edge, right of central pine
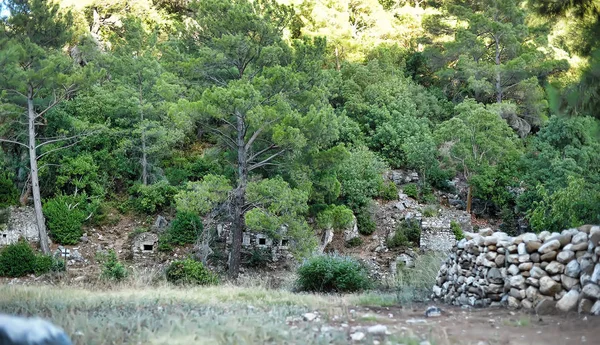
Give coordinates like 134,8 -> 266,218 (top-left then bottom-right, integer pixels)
297,255 -> 372,293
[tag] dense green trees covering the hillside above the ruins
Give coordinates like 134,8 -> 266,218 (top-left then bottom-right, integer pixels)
0,0 -> 600,276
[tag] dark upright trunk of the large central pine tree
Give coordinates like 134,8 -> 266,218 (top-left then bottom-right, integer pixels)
229,114 -> 248,278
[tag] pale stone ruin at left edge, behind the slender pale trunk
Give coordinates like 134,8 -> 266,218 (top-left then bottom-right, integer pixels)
0,207 -> 40,246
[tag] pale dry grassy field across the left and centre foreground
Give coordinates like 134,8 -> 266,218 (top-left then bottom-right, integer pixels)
0,285 -> 410,345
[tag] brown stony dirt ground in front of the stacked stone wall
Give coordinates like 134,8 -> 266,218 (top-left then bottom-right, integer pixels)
340,305 -> 600,345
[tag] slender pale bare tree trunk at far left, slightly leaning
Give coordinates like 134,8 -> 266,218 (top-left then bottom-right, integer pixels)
27,87 -> 50,254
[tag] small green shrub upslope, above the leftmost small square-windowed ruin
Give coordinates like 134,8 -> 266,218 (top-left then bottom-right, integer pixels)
129,181 -> 177,214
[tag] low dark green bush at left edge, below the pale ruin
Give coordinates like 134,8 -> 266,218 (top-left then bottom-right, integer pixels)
0,239 -> 53,277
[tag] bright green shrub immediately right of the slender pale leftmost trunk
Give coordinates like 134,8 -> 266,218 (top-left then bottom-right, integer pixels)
44,194 -> 94,244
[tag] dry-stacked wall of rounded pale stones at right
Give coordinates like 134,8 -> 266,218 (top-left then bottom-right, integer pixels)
433,225 -> 600,315
